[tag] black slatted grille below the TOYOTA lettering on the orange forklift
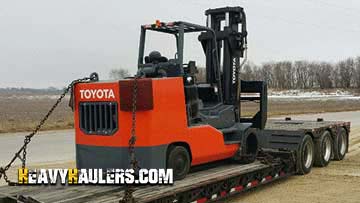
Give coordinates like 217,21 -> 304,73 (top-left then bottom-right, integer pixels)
79,102 -> 118,135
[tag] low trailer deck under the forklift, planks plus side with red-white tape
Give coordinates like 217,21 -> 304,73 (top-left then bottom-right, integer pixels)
0,161 -> 290,203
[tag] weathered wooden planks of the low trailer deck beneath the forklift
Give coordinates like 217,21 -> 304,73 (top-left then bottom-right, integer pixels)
0,161 -> 270,203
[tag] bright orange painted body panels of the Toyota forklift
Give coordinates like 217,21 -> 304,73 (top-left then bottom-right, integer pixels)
74,78 -> 239,165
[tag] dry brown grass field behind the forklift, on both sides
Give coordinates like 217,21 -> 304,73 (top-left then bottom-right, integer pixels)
0,95 -> 360,133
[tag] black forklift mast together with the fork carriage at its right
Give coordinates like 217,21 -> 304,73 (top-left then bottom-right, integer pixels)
199,7 -> 267,129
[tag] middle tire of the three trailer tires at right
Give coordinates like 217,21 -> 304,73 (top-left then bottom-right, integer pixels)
314,130 -> 334,167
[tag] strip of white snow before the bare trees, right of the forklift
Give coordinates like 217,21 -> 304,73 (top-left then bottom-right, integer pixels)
268,90 -> 360,100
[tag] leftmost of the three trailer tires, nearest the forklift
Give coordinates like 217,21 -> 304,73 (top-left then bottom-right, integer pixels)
296,134 -> 315,175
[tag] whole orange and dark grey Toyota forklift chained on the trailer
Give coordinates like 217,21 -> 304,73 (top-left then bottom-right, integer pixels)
73,7 -> 320,180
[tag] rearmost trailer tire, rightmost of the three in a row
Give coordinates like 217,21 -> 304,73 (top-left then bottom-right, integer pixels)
334,128 -> 349,161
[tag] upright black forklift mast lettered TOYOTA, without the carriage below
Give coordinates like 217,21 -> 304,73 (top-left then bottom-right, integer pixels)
199,7 -> 247,105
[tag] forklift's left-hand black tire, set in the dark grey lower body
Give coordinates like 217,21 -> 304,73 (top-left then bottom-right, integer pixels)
167,146 -> 191,180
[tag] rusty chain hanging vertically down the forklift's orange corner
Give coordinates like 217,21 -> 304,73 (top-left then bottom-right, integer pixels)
119,74 -> 140,203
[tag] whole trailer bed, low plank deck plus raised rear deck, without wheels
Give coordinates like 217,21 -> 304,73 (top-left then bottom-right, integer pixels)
0,119 -> 350,203
